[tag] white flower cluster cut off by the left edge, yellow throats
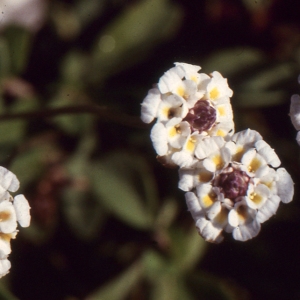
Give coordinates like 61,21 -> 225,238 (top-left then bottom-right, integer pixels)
0,167 -> 30,278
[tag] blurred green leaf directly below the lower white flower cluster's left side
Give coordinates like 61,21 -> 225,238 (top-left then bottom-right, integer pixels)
170,228 -> 208,272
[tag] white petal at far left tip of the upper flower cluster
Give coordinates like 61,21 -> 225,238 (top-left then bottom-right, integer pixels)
141,88 -> 161,123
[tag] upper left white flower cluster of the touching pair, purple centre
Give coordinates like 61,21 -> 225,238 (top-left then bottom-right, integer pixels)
141,63 -> 234,167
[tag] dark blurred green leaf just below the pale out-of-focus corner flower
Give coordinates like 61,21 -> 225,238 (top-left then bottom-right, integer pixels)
1,26 -> 32,75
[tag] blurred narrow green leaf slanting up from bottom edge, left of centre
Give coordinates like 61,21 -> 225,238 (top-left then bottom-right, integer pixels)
86,262 -> 143,300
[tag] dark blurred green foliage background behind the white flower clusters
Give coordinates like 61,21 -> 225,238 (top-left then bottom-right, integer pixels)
0,0 -> 300,300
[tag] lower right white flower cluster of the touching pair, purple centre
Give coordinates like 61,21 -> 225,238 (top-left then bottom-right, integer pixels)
184,130 -> 294,242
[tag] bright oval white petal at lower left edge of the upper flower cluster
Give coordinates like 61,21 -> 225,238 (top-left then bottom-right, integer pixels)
150,123 -> 168,156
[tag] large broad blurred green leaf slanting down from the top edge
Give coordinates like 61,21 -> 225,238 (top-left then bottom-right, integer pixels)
87,0 -> 181,82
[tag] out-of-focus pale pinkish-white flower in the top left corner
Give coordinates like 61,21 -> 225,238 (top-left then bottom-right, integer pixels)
0,0 -> 47,32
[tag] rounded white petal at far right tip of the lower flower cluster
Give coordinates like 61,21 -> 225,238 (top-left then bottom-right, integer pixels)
277,168 -> 294,203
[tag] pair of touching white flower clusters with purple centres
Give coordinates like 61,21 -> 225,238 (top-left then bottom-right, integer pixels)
141,63 -> 294,243
